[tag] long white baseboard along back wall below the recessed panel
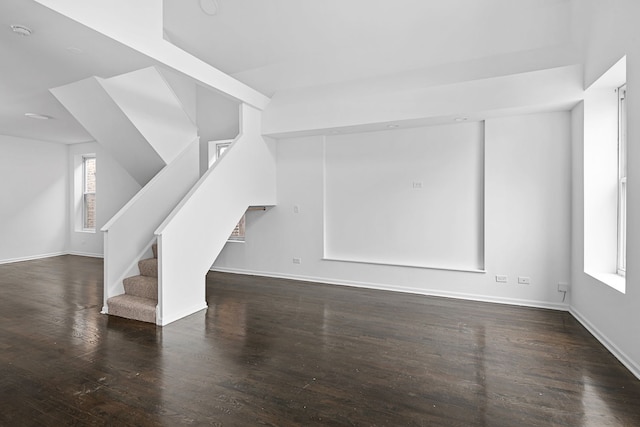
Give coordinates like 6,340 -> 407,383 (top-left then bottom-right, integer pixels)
211,267 -> 569,311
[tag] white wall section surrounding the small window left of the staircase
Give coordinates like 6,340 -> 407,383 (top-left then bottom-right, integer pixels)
65,142 -> 141,257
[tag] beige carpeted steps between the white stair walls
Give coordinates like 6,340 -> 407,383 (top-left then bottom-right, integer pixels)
107,243 -> 158,323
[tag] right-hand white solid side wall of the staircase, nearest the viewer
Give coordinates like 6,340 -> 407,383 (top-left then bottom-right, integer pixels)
155,104 -> 276,325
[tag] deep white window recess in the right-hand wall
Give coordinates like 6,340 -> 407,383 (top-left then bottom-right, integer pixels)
578,57 -> 627,293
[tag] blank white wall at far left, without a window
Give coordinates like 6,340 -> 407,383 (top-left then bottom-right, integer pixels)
0,135 -> 68,263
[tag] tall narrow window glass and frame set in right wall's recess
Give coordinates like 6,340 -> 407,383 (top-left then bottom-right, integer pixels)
618,85 -> 627,276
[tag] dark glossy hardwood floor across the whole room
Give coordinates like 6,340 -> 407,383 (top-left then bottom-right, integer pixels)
0,256 -> 640,426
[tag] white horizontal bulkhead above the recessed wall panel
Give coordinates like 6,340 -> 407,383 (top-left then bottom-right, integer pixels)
262,65 -> 582,137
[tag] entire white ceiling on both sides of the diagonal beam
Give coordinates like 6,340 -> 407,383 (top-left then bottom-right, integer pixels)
0,0 -> 579,143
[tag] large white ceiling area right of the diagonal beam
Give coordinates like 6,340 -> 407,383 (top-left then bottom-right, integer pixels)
163,0 -> 572,96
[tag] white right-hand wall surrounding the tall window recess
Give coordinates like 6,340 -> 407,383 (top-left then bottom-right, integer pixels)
571,0 -> 640,377
